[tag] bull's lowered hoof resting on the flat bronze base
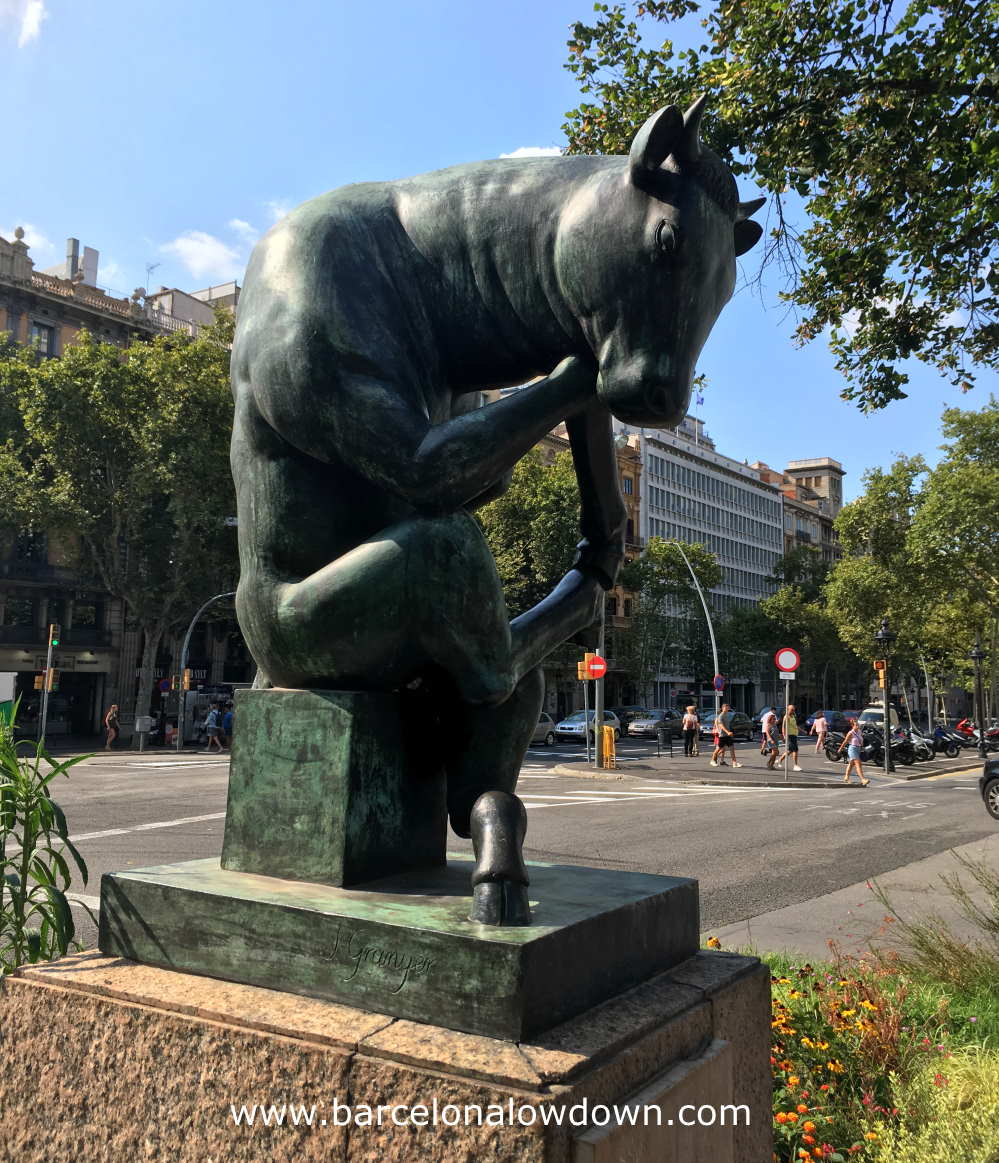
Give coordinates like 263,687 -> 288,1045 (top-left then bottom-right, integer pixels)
469,792 -> 530,925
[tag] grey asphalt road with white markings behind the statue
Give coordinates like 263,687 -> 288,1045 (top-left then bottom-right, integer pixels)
52,741 -> 997,946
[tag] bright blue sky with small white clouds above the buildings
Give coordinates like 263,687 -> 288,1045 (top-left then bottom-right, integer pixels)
0,0 -> 999,497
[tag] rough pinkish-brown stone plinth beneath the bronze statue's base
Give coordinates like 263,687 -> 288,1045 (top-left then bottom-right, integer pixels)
0,954 -> 771,1163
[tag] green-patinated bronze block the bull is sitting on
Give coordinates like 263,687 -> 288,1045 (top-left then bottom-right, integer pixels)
222,690 -> 445,885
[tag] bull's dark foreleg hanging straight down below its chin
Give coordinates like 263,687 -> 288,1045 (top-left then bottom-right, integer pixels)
566,400 -> 628,590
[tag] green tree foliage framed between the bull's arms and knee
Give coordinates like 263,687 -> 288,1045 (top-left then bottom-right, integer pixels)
478,450 -> 580,618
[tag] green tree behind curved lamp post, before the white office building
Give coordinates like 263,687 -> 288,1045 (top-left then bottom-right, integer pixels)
615,537 -> 721,698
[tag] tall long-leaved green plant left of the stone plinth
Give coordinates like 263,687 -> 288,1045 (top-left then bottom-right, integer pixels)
0,704 -> 88,976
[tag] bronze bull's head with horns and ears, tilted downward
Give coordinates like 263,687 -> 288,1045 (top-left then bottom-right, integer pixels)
556,98 -> 765,427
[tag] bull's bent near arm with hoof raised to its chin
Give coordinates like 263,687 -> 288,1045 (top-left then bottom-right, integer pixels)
249,339 -> 597,513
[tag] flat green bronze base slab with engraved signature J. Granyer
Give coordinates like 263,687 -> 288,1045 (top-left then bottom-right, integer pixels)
100,855 -> 698,1041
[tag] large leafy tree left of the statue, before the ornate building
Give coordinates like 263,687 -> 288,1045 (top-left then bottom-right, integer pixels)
0,316 -> 236,714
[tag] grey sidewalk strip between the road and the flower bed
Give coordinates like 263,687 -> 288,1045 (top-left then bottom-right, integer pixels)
704,832 -> 999,961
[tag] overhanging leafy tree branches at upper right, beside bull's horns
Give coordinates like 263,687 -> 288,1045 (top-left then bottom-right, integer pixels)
565,0 -> 999,409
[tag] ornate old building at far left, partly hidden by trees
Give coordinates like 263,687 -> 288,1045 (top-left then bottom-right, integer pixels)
0,228 -> 247,735
